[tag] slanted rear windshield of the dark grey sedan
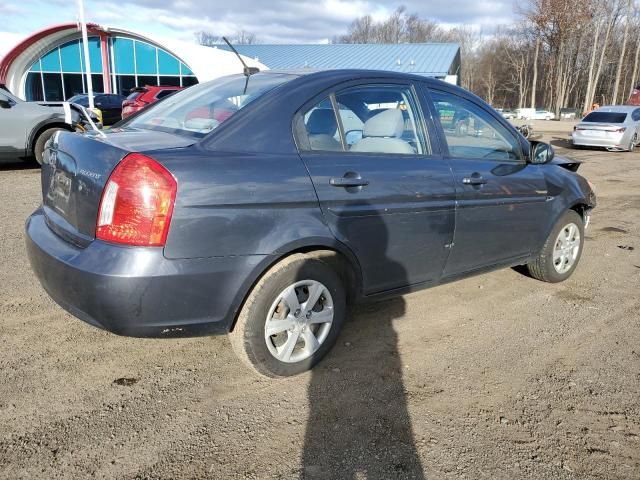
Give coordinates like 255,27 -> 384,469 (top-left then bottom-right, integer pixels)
125,73 -> 295,138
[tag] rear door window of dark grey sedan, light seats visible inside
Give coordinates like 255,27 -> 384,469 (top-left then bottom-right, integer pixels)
303,85 -> 428,155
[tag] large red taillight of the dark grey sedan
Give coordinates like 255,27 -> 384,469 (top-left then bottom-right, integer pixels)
96,153 -> 177,246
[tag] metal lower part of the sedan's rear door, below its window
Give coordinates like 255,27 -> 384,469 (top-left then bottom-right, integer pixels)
302,153 -> 455,294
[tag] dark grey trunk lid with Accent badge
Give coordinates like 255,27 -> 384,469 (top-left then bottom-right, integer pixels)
41,129 -> 195,247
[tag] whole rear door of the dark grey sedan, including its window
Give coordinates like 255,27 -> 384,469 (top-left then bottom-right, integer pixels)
299,84 -> 455,294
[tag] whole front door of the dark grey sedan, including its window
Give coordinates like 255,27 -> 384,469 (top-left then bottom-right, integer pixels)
430,90 -> 549,276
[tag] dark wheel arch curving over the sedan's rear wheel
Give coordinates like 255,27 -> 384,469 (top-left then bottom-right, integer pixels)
229,239 -> 363,332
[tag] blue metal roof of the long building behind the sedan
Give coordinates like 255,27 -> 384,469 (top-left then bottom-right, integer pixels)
218,43 -> 460,77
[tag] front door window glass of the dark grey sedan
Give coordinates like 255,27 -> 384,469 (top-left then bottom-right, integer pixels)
430,90 -> 522,161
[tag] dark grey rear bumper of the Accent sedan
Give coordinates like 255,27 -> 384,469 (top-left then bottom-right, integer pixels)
26,209 -> 265,337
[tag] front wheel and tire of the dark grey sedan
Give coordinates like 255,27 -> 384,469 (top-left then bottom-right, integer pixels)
527,210 -> 584,283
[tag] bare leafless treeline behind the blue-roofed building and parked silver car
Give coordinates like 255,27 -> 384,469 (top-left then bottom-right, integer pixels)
333,0 -> 640,114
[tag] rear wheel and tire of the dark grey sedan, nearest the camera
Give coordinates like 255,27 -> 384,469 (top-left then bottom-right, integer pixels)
230,254 -> 346,377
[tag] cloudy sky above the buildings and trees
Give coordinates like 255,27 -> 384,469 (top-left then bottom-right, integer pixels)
0,0 -> 516,56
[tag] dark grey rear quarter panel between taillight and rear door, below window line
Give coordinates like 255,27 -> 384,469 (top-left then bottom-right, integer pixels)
156,146 -> 335,258
